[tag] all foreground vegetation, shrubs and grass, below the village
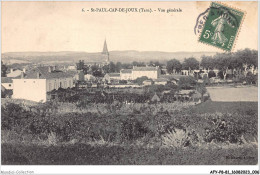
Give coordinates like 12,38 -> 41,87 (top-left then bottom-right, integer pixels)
1,98 -> 257,165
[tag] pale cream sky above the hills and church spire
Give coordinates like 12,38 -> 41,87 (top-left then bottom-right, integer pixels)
1,2 -> 258,53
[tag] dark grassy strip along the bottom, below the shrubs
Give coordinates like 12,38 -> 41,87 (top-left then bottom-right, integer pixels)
2,143 -> 257,165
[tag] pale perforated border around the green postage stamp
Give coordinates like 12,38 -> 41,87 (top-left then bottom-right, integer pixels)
198,1 -> 246,52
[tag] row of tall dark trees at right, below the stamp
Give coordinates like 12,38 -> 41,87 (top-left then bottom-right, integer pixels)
166,49 -> 258,80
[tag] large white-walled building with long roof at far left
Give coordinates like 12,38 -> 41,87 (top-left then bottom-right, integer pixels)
13,67 -> 73,102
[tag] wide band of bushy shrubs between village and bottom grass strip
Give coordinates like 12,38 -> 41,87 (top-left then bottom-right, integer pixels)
2,101 -> 257,145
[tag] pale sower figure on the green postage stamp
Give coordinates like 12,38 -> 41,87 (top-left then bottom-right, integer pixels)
211,12 -> 234,46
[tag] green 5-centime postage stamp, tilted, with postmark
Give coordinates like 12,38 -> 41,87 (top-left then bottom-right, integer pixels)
199,2 -> 245,51
